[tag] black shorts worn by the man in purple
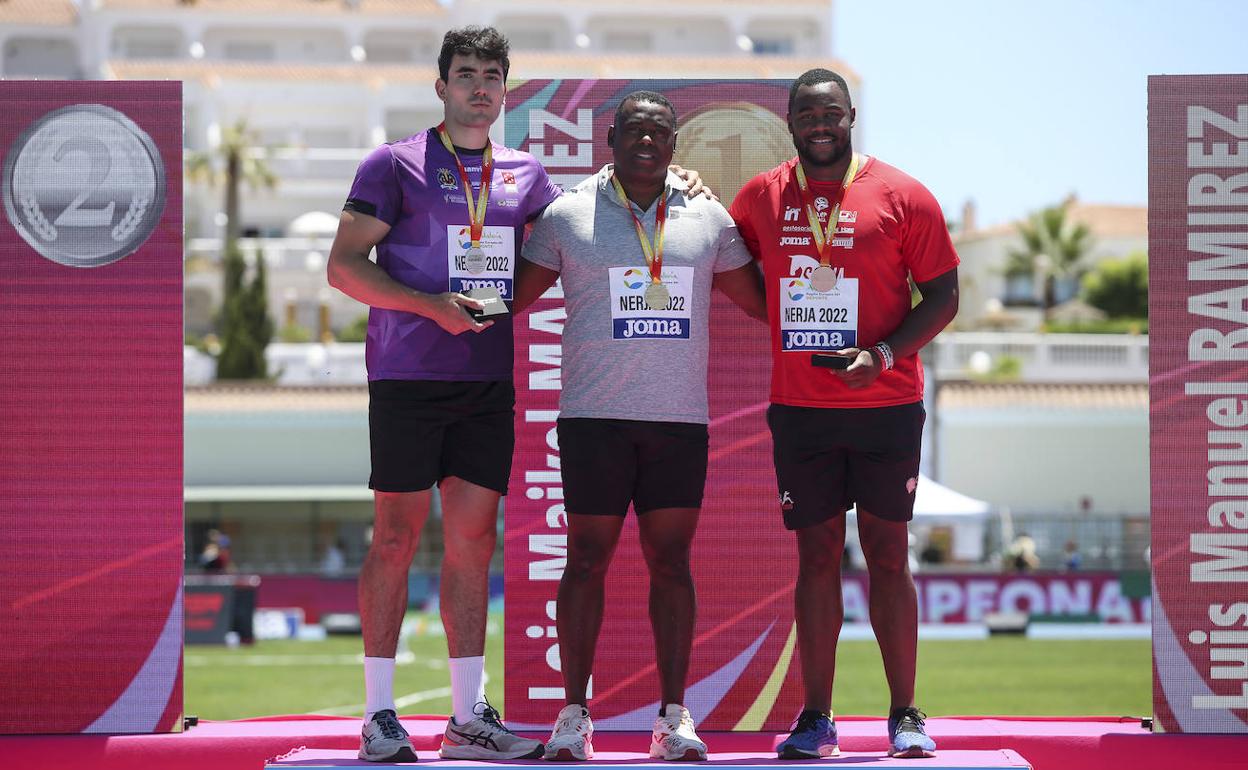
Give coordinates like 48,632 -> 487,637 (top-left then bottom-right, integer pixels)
368,379 -> 515,494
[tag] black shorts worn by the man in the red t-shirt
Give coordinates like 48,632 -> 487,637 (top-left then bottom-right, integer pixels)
768,402 -> 926,529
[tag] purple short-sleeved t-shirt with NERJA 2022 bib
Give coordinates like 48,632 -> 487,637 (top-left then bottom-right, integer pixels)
346,129 -> 560,382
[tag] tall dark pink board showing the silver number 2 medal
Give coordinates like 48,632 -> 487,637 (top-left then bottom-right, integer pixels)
0,81 -> 183,734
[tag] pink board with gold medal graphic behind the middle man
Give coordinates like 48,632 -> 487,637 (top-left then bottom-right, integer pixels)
504,80 -> 793,730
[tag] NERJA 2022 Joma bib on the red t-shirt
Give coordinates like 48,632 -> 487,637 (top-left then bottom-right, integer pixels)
780,277 -> 859,351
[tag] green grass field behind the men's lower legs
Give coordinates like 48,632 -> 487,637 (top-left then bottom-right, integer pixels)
185,614 -> 1152,719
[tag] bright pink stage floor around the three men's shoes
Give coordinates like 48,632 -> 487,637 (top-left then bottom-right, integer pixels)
0,716 -> 1248,770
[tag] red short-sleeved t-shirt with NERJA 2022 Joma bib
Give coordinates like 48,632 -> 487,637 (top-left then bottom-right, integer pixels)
729,157 -> 958,408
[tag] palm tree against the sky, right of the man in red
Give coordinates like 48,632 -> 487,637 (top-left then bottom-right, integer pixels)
1006,201 -> 1092,319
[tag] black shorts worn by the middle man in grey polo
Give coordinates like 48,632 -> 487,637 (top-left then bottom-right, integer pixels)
557,417 -> 710,515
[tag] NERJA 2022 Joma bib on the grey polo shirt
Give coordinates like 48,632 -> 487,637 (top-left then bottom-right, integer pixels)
608,266 -> 694,339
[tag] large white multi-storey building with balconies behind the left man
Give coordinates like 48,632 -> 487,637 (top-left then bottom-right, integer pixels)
0,0 -> 857,332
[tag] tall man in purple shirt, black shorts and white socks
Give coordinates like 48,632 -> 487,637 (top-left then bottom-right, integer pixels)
328,27 -> 559,761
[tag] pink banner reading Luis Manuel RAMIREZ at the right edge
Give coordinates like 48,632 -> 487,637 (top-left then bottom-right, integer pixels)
1148,75 -> 1248,733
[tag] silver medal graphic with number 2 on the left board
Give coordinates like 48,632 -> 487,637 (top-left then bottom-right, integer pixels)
4,105 -> 165,267
